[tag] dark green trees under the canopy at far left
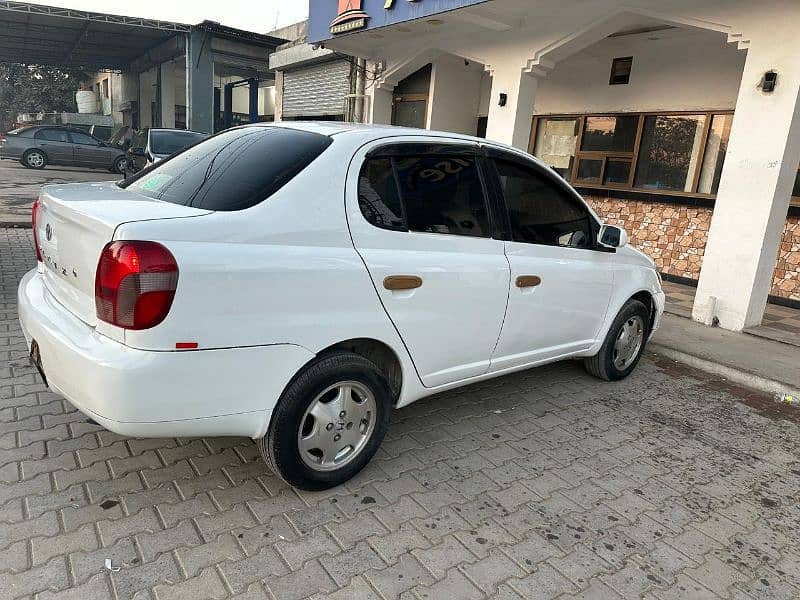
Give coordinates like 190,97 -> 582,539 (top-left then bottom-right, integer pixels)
0,63 -> 83,131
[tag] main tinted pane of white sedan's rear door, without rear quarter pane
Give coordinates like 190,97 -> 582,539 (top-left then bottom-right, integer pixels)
393,156 -> 490,237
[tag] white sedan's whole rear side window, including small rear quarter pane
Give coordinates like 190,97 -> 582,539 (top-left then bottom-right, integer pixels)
359,156 -> 491,237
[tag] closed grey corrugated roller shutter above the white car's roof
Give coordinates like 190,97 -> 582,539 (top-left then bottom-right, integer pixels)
283,60 -> 350,118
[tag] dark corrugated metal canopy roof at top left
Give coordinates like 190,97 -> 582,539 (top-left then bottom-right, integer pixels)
0,0 -> 192,70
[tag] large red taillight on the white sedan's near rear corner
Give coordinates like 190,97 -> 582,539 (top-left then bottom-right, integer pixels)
94,241 -> 178,330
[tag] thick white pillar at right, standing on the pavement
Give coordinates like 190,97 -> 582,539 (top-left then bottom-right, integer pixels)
692,38 -> 800,331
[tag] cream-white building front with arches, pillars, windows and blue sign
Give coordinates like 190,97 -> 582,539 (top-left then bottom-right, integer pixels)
309,0 -> 800,330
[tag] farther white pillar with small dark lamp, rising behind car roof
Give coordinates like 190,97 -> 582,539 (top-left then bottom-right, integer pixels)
486,61 -> 538,150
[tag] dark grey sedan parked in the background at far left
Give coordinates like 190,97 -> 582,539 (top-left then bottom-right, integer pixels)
0,125 -> 126,173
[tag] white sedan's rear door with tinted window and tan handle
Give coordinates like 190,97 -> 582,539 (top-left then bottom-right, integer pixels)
347,138 -> 509,387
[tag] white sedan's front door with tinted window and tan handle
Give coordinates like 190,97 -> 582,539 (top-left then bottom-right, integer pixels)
484,152 -> 614,371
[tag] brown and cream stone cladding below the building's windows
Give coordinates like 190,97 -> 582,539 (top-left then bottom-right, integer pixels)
585,195 -> 800,301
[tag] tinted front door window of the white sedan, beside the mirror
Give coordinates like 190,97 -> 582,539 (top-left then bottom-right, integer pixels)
495,160 -> 593,248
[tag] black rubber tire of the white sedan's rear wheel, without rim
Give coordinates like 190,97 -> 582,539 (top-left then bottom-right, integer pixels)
256,352 -> 392,491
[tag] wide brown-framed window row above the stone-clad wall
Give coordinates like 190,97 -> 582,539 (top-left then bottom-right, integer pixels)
530,112 -> 736,197
